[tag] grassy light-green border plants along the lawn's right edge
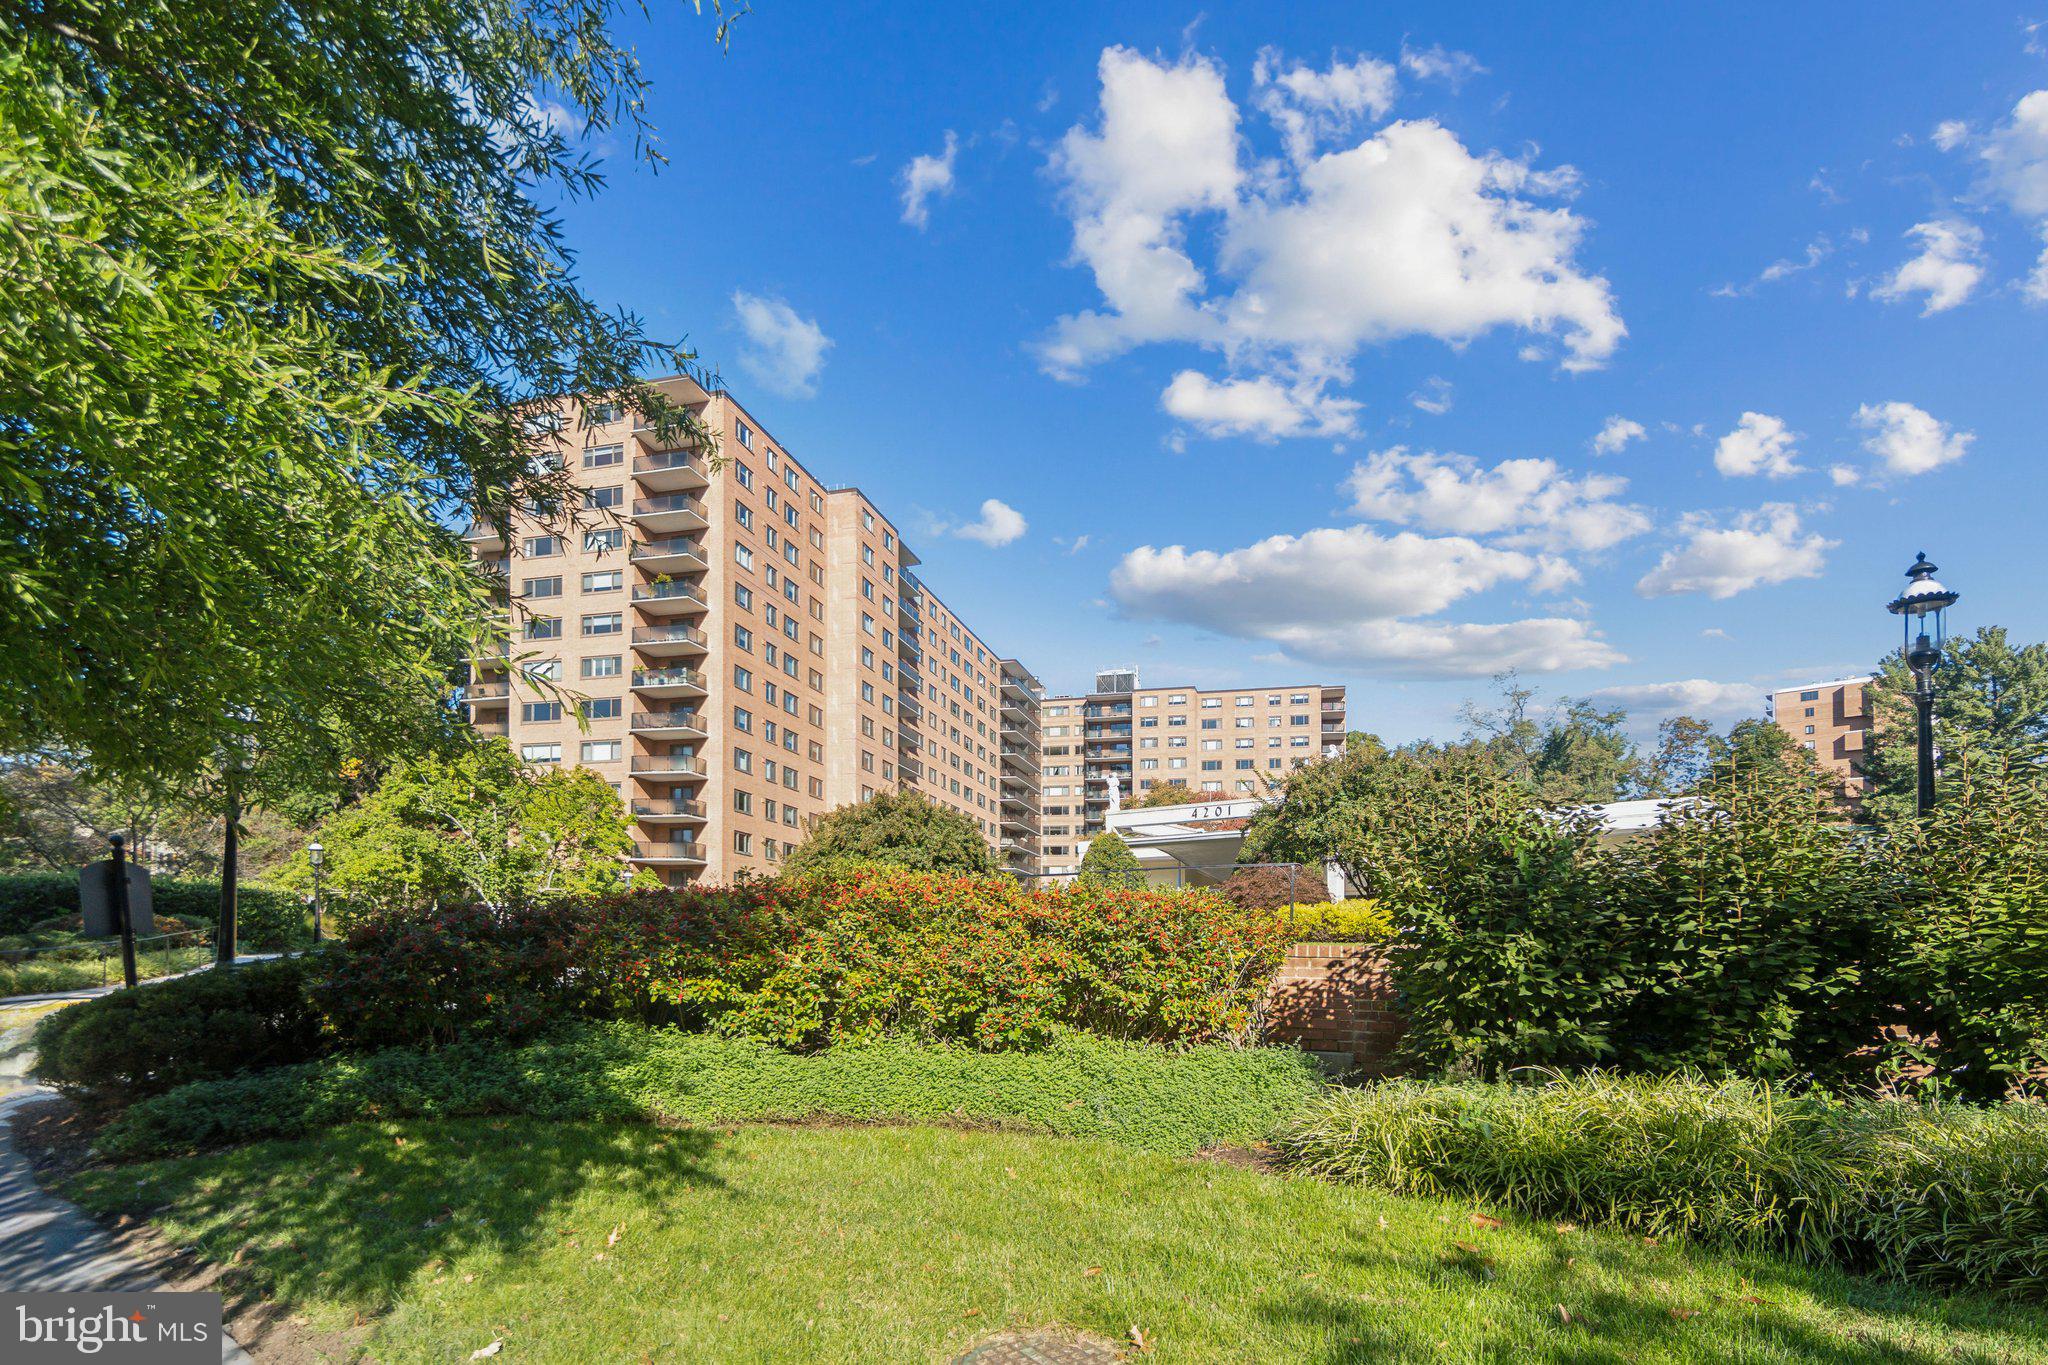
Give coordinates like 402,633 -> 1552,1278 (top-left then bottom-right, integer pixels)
1276,1072 -> 2048,1293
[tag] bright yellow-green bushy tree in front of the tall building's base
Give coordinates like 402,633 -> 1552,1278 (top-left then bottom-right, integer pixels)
279,739 -> 638,909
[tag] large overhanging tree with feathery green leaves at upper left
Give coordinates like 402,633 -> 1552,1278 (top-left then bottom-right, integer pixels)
0,0 -> 723,786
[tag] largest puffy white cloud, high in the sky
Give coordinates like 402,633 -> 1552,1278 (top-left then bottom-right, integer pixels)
1038,47 -> 1626,392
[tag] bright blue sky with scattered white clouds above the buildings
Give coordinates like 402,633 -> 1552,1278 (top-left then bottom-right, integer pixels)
567,0 -> 2048,739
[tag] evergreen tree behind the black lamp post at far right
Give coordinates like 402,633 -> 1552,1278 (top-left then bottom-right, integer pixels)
1864,626 -> 2048,823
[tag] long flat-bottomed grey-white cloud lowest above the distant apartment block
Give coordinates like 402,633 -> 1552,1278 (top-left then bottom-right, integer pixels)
1110,526 -> 1620,677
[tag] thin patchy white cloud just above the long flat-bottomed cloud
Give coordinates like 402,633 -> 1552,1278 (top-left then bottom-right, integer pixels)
1343,446 -> 1651,551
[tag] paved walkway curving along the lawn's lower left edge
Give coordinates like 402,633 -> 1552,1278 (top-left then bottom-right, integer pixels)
0,1015 -> 252,1365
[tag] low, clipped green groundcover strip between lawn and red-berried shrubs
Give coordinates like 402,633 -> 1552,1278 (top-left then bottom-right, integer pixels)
100,1023 -> 1319,1156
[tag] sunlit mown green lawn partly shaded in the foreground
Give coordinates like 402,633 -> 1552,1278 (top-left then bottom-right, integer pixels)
72,1119 -> 2048,1363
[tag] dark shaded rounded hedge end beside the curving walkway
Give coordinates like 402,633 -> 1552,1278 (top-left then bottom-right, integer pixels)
35,958 -> 322,1101
